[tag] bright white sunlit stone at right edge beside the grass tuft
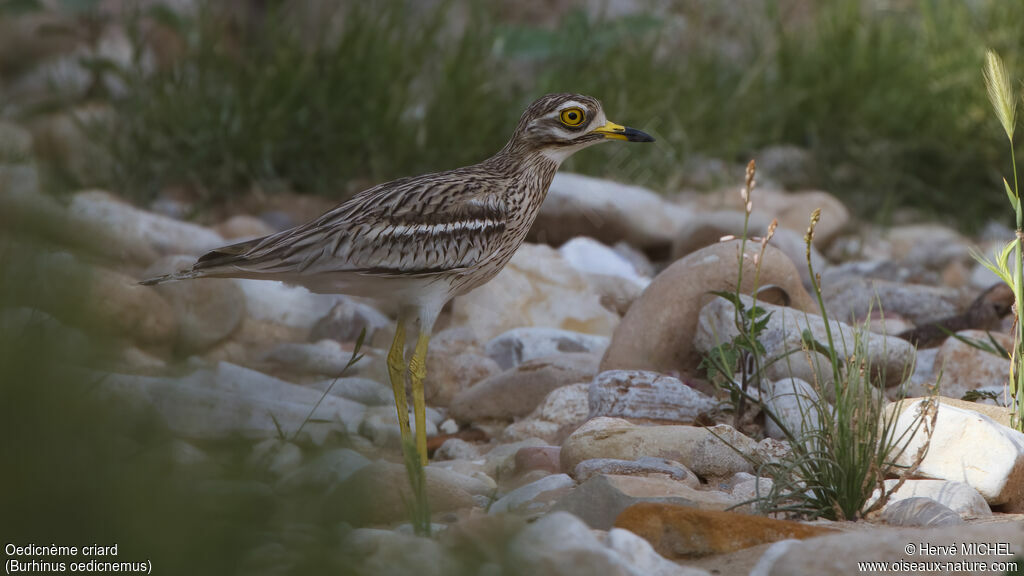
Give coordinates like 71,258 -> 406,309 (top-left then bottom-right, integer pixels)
894,400 -> 1024,507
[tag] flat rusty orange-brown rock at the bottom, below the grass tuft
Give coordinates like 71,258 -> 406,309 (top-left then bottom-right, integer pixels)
615,502 -> 835,558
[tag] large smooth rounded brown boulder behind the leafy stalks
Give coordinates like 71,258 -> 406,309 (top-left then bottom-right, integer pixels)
601,241 -> 817,376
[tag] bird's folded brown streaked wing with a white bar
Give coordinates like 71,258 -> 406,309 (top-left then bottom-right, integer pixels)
195,173 -> 507,276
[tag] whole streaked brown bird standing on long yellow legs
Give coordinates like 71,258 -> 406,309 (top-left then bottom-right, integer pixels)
141,93 -> 654,465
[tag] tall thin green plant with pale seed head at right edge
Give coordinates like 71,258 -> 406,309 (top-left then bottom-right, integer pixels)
973,50 -> 1024,430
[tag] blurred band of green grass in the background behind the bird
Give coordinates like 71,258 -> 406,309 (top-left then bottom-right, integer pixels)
14,0 -> 1024,228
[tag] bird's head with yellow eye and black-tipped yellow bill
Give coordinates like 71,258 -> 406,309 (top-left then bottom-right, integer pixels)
512,94 -> 654,163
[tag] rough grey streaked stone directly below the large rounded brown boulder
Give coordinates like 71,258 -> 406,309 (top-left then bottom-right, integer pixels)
590,370 -> 719,423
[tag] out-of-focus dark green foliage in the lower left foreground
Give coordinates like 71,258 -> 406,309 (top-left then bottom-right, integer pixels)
0,239 -> 364,575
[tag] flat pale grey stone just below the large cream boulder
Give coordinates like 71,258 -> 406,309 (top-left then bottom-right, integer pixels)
486,326 -> 608,370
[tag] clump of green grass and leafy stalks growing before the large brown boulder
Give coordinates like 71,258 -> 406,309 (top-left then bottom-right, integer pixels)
702,168 -> 937,520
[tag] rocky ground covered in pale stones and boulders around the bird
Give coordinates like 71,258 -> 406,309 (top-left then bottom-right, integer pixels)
0,109 -> 1024,576
